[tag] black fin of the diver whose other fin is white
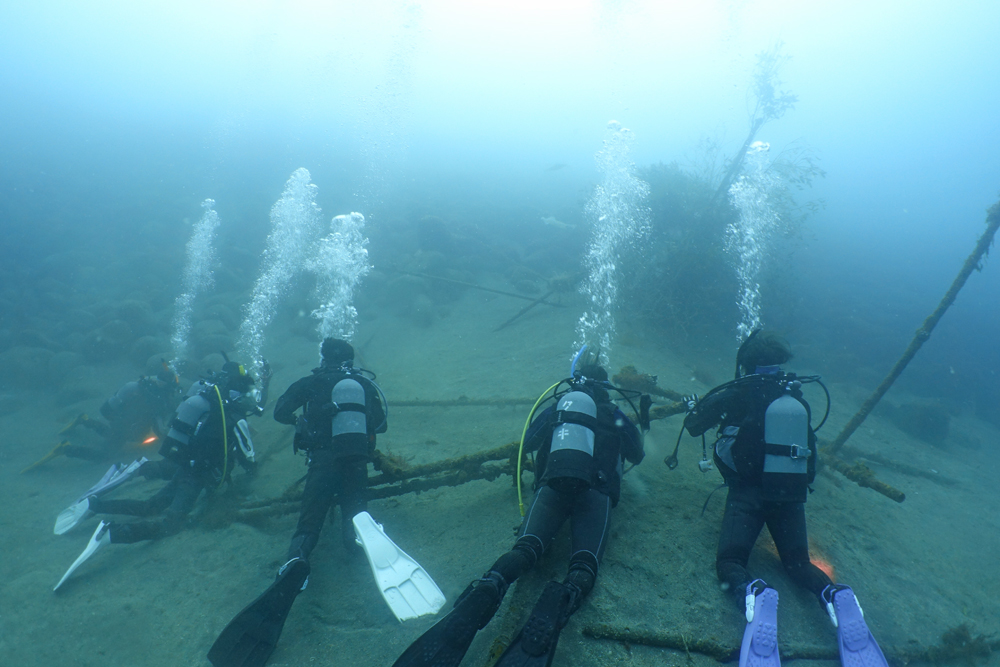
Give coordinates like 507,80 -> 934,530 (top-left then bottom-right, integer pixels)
208,558 -> 309,667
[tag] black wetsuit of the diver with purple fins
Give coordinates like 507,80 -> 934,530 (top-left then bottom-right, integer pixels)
684,375 -> 831,603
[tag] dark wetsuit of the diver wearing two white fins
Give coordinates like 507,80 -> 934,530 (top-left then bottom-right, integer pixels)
90,385 -> 252,543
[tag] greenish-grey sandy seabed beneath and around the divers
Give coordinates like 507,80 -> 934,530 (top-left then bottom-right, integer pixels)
0,292 -> 1000,667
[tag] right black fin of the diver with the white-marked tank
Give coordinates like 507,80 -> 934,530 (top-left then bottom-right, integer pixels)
495,581 -> 579,667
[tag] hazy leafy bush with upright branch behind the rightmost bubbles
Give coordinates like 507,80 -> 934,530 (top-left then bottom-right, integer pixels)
620,43 -> 826,337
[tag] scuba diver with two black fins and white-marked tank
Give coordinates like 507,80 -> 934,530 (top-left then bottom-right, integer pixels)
394,345 -> 650,667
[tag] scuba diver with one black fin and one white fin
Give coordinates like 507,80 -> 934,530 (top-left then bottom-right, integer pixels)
208,338 -> 445,667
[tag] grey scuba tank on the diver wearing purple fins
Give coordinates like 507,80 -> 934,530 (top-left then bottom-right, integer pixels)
762,382 -> 812,502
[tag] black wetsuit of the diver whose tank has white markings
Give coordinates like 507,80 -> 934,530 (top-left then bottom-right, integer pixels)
490,388 -> 645,610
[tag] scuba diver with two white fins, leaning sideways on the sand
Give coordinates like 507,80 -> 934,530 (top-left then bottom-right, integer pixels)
53,357 -> 266,590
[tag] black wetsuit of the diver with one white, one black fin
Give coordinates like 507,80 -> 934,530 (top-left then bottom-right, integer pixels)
274,366 -> 386,559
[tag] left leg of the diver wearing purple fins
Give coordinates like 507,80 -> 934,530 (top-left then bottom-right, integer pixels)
715,483 -> 764,604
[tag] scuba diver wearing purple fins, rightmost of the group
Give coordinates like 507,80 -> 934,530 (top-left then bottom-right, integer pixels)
665,329 -> 886,667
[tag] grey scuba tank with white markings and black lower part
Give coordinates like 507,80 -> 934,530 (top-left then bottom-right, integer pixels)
545,391 -> 597,491
